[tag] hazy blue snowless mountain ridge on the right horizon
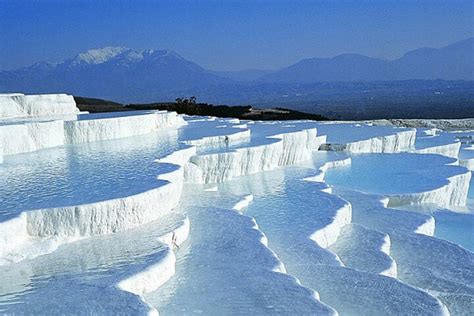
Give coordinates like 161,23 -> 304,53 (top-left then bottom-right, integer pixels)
259,38 -> 474,83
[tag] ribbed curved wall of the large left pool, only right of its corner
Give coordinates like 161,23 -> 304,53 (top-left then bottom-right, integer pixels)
26,167 -> 183,237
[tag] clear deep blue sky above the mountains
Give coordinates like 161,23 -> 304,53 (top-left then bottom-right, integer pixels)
0,0 -> 474,70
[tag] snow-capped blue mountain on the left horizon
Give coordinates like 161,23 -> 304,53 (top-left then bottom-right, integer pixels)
0,47 -> 230,100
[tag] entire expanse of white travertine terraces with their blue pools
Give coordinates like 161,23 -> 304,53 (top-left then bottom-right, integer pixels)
0,94 -> 474,315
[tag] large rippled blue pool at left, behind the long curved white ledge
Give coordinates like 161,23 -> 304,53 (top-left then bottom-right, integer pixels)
0,131 -> 183,221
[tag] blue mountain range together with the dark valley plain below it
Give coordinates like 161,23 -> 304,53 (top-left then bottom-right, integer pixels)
0,38 -> 474,119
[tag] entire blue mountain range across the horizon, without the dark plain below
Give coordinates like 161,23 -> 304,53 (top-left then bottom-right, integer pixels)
0,38 -> 474,102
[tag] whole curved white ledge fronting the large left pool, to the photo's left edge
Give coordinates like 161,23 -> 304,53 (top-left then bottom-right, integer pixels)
0,166 -> 189,265
